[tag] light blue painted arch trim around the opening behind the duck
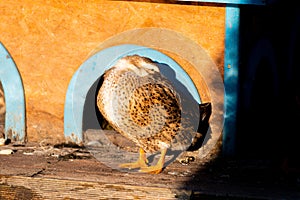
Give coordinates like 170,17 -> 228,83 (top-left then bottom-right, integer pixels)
64,44 -> 200,144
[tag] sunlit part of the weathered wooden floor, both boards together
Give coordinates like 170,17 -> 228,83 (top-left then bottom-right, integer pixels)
0,140 -> 216,199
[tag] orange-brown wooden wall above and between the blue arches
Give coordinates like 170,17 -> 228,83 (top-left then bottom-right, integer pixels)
0,0 -> 225,143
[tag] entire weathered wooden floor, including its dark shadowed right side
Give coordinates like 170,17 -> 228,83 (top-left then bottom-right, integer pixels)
0,141 -> 300,199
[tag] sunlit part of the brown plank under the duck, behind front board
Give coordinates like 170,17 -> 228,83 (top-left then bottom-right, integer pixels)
0,142 -> 214,189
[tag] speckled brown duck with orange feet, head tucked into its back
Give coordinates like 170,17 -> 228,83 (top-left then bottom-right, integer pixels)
97,55 -> 199,174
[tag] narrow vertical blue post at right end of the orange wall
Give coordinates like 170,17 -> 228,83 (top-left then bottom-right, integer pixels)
223,6 -> 240,155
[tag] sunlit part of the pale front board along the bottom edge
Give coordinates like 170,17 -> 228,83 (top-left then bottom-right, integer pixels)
0,176 -> 191,200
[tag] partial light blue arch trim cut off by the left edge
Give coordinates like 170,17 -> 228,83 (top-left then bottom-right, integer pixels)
0,42 -> 26,142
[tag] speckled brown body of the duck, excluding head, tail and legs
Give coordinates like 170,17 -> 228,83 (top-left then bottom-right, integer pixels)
97,66 -> 181,149
